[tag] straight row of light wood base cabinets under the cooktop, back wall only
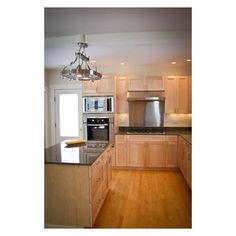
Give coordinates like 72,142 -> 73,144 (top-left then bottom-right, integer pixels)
116,135 -> 175,168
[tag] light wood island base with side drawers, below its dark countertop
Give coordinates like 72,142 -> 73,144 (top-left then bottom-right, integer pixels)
45,145 -> 112,228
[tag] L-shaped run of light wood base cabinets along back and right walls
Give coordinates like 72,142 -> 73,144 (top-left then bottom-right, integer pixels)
115,135 -> 192,188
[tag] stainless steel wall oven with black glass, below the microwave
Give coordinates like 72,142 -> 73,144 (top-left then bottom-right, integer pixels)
83,117 -> 114,147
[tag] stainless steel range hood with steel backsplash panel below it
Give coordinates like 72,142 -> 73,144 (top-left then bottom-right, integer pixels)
127,90 -> 165,127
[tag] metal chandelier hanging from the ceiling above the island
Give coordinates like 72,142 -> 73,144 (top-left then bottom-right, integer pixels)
61,36 -> 102,81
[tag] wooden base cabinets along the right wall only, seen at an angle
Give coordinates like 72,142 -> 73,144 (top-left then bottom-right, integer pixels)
178,137 -> 192,188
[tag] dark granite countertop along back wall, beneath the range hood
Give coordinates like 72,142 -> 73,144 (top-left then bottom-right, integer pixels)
116,126 -> 192,144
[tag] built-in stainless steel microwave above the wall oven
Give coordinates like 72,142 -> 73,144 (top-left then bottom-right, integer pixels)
83,96 -> 114,113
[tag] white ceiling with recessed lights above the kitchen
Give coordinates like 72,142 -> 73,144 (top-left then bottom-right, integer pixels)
45,8 -> 191,71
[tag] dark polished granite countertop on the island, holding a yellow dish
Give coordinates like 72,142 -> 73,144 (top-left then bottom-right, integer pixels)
45,141 -> 109,165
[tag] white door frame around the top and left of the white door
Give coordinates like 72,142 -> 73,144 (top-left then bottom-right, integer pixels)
48,83 -> 82,146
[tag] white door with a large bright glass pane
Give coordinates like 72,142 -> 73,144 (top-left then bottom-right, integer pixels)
54,89 -> 82,143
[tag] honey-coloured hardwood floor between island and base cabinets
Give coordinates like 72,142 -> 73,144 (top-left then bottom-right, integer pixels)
94,170 -> 191,228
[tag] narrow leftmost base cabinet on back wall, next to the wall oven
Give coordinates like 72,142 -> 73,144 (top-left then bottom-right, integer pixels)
115,135 -> 127,167
